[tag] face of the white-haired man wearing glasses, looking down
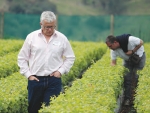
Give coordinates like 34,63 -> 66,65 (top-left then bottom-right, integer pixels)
40,20 -> 56,36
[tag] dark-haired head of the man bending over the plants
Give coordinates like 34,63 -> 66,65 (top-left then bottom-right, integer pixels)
106,35 -> 120,50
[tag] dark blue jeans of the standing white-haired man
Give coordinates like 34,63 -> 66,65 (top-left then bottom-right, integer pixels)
28,76 -> 61,113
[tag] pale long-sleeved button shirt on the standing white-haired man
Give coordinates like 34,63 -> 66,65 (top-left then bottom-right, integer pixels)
18,29 -> 75,78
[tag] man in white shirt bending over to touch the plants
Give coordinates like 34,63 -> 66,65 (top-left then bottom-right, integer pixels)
106,34 -> 146,105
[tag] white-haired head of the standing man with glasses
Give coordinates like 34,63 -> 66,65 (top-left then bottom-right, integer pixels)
40,11 -> 56,36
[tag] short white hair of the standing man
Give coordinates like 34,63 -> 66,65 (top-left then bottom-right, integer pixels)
40,11 -> 56,22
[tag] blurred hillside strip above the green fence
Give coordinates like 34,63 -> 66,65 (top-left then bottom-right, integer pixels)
0,0 -> 150,15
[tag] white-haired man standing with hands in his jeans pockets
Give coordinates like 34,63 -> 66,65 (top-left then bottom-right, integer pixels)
18,11 -> 75,113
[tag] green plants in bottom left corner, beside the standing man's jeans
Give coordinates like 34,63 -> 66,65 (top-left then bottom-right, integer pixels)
0,72 -> 28,113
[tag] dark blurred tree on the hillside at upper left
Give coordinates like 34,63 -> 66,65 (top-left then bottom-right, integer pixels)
7,0 -> 57,14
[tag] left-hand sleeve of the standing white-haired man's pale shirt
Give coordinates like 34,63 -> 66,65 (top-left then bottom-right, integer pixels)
18,36 -> 31,78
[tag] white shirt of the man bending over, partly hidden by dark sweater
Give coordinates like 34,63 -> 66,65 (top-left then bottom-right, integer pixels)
111,36 -> 144,60
